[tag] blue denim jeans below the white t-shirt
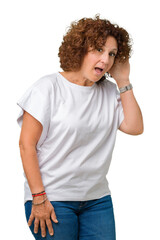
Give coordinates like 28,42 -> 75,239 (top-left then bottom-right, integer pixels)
25,195 -> 116,240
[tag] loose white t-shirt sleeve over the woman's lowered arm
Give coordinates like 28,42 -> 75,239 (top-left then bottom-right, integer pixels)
17,79 -> 50,147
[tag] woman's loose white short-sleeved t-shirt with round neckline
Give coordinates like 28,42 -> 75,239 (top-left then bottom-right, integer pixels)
17,72 -> 124,202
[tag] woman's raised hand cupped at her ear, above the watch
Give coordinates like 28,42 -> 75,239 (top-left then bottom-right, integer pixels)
108,59 -> 130,88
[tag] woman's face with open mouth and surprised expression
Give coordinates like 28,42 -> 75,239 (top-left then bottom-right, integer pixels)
80,36 -> 118,82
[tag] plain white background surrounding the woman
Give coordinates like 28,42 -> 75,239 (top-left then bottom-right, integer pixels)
0,0 -> 160,240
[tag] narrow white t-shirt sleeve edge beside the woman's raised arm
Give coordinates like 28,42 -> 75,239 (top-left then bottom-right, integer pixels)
116,87 -> 124,128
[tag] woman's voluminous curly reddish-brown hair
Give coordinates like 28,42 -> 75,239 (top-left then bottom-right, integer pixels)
58,15 -> 132,82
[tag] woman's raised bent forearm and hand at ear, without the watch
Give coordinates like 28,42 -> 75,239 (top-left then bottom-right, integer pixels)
109,59 -> 143,135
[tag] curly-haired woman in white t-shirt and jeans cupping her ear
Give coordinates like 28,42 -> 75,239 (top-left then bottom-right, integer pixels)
17,16 -> 143,240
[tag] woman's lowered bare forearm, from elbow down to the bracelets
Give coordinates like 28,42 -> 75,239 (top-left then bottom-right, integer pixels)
19,144 -> 44,193
